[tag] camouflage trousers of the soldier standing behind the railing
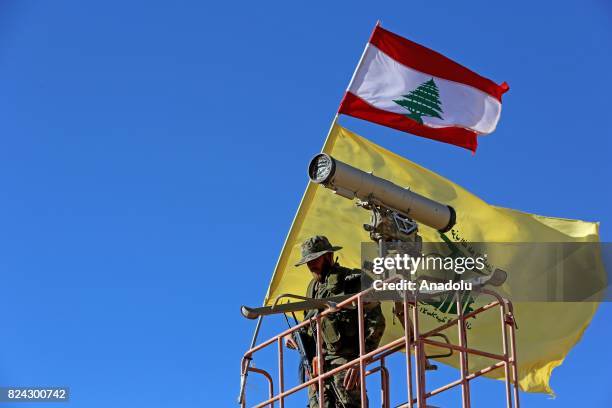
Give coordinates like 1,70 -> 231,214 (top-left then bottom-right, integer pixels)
308,357 -> 367,408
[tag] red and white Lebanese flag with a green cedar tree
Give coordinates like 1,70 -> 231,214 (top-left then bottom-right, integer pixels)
338,25 -> 509,152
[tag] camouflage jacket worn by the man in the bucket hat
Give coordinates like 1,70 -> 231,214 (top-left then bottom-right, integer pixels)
306,263 -> 385,360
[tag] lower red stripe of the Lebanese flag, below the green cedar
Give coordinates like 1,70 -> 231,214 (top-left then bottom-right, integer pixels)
338,92 -> 478,153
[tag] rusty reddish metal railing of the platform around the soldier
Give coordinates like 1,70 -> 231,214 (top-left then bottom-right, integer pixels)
241,289 -> 519,408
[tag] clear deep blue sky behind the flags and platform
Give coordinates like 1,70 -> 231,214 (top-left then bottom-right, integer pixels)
0,0 -> 612,408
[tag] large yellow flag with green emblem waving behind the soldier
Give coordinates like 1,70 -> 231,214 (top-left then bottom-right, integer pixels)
265,125 -> 599,393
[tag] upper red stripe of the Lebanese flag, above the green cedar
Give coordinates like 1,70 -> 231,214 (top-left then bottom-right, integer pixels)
370,26 -> 510,102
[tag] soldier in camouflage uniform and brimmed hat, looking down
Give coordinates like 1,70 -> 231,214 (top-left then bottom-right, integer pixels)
286,235 -> 385,408
